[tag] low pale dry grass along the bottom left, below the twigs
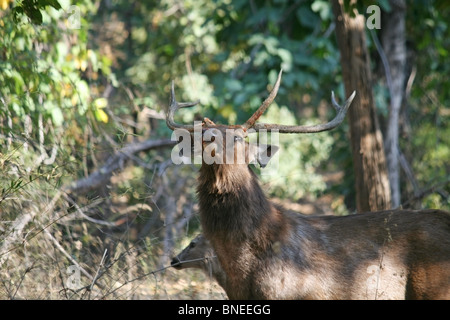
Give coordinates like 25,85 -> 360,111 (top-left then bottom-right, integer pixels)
0,212 -> 226,300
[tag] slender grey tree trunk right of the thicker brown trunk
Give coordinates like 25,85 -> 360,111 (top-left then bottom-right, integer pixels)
381,0 -> 406,208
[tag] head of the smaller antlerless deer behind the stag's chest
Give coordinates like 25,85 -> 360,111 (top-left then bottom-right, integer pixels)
170,234 -> 226,289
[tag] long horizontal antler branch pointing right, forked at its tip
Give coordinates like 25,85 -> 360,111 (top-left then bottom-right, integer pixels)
253,91 -> 356,133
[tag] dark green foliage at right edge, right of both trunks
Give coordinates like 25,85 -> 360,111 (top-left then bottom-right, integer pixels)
402,1 -> 450,209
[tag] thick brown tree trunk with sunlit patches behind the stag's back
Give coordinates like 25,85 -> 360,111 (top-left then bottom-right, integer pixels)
333,0 -> 391,212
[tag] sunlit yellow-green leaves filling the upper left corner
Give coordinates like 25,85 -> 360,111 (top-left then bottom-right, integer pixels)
0,1 -> 110,128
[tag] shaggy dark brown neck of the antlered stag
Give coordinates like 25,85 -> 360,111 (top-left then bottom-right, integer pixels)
197,164 -> 282,249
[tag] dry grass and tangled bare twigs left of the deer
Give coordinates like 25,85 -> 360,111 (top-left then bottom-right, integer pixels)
0,142 -> 226,300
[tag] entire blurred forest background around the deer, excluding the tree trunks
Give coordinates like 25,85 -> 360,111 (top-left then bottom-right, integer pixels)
0,0 -> 450,299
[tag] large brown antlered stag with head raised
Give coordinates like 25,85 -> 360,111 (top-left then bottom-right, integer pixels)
166,72 -> 450,299
